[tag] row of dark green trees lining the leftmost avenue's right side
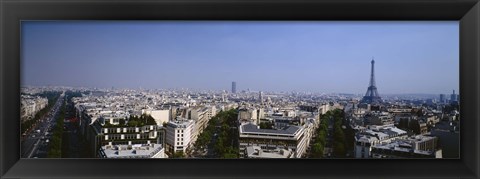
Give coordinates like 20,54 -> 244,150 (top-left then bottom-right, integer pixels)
47,98 -> 66,158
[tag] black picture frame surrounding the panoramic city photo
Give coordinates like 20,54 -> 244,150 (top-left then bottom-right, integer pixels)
0,0 -> 480,178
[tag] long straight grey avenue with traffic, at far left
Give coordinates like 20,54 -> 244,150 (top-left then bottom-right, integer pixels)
21,93 -> 64,158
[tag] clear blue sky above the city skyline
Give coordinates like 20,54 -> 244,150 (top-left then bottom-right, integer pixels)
21,21 -> 459,94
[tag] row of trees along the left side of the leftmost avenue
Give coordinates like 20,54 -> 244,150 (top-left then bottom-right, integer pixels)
20,91 -> 60,134
